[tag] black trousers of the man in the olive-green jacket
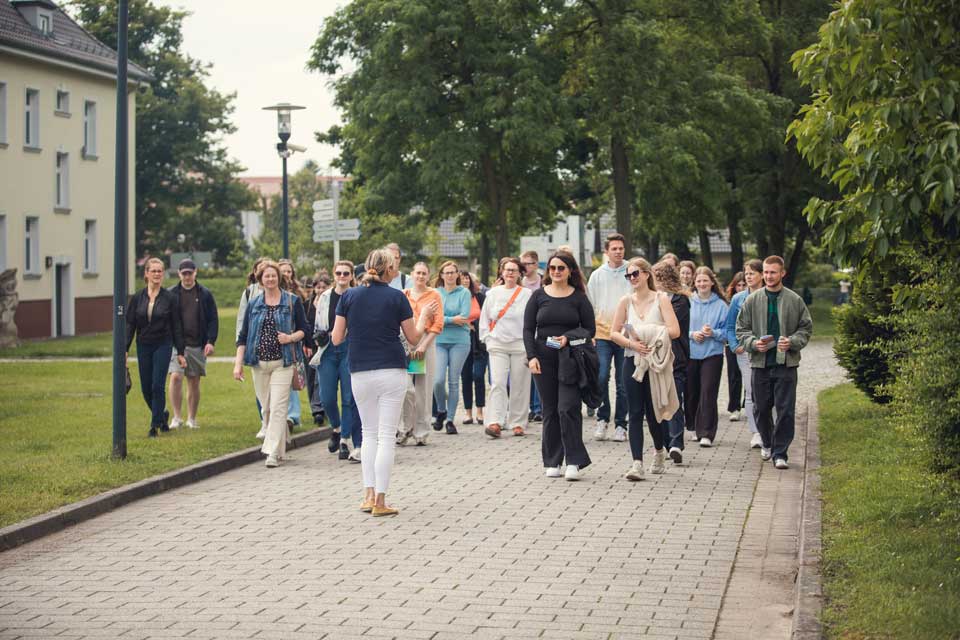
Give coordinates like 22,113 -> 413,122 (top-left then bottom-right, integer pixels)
751,367 -> 797,460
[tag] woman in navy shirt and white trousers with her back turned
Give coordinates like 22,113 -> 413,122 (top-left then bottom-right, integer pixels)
330,248 -> 439,516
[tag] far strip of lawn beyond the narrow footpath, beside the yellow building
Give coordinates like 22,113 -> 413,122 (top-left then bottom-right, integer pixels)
0,278 -> 243,358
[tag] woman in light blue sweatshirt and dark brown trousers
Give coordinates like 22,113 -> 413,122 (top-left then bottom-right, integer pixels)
686,267 -> 727,447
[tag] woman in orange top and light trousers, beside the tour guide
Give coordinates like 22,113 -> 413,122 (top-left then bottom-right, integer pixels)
397,262 -> 443,447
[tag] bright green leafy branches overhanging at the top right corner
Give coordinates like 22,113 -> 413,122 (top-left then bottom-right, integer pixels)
789,0 -> 960,277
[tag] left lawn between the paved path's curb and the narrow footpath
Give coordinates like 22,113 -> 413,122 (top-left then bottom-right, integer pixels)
0,362 -> 310,526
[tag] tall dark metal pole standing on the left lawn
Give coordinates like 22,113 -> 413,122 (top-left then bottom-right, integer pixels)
113,0 -> 129,460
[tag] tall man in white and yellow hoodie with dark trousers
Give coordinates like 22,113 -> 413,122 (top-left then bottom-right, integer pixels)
587,233 -> 631,442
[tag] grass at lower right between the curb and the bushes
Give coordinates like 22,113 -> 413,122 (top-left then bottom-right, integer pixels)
819,384 -> 960,639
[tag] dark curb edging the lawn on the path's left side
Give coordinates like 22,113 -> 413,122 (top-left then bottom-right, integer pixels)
0,427 -> 331,552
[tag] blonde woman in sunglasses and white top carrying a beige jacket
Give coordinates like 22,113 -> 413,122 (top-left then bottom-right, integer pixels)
610,258 -> 680,480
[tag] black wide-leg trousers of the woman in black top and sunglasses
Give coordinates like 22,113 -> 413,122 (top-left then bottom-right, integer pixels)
533,342 -> 590,469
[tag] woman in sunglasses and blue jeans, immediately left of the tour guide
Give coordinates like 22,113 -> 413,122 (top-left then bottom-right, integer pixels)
310,260 -> 362,462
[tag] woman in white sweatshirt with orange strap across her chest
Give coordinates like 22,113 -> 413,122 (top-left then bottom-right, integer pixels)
479,257 -> 533,438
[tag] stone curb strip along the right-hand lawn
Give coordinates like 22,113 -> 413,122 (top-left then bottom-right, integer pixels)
791,397 -> 823,640
